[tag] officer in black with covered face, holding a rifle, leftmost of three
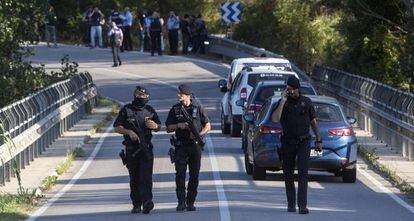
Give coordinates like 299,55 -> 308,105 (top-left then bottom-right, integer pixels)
114,86 -> 161,214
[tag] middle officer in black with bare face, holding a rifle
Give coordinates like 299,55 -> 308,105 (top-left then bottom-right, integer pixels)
165,84 -> 211,211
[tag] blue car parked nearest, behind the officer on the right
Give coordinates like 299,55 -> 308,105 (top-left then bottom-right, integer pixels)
244,95 -> 358,183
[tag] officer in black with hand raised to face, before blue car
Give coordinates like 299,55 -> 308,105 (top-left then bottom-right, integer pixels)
272,76 -> 322,214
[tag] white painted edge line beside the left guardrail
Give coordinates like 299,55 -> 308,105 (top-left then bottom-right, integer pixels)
26,122 -> 113,221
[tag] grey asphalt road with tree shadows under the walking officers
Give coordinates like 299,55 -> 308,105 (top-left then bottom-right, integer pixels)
26,45 -> 414,221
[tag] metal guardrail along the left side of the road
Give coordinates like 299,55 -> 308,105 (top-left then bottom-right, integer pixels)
0,73 -> 97,185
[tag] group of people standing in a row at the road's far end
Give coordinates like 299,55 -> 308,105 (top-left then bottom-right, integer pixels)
83,6 -> 208,56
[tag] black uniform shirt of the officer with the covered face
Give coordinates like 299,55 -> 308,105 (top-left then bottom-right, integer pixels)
113,104 -> 161,145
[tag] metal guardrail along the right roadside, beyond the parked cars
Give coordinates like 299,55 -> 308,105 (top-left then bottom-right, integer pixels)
207,35 -> 414,160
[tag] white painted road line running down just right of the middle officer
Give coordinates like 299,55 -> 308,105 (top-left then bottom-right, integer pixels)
206,134 -> 231,221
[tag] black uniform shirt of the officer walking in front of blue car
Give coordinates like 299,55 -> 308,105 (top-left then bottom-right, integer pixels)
278,95 -> 315,138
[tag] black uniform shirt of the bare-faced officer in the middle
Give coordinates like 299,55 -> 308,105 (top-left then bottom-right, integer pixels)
165,103 -> 210,141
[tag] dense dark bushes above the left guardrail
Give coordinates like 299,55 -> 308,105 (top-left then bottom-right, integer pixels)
0,0 -> 86,107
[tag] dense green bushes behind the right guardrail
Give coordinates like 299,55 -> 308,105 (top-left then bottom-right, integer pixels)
234,0 -> 414,91
